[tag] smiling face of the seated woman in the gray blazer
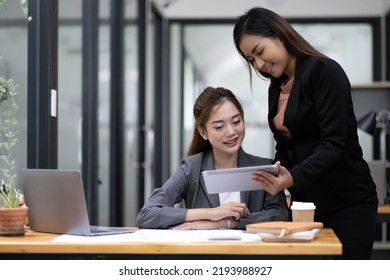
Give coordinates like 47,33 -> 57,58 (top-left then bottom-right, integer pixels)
198,101 -> 245,158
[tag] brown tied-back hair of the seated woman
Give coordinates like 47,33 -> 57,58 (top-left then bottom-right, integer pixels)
187,87 -> 244,156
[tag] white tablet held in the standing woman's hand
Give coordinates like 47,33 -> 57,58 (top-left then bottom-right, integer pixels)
202,164 -> 278,194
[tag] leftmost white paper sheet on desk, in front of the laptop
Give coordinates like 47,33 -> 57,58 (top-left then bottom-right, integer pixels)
52,233 -> 132,243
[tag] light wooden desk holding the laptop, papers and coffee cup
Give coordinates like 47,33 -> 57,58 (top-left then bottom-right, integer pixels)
0,228 -> 342,259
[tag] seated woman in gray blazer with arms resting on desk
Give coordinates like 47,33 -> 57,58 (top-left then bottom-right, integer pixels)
137,87 -> 289,229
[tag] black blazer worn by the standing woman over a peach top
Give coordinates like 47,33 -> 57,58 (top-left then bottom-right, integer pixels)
268,57 -> 377,215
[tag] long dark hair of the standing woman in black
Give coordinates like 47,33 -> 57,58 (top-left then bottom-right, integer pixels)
233,7 -> 326,82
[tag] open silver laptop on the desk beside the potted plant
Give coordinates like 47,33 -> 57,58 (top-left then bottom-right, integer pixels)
20,169 -> 135,236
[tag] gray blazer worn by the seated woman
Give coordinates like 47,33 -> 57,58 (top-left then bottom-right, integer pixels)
137,149 -> 289,229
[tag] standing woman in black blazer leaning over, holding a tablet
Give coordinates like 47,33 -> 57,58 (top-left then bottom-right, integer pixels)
233,8 -> 378,259
